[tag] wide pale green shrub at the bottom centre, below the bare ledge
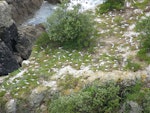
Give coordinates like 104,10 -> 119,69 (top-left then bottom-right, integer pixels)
49,83 -> 120,113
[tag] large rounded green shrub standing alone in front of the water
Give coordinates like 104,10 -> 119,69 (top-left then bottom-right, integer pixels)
45,3 -> 96,48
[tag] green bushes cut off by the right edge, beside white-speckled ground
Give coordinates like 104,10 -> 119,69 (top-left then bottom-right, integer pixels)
136,17 -> 150,63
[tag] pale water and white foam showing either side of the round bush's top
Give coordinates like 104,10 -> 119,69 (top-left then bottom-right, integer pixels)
24,0 -> 104,25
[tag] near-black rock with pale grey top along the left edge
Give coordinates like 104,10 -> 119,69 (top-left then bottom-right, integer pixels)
0,1 -> 19,75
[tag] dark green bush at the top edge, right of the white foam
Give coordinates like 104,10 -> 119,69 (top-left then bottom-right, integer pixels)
96,0 -> 125,14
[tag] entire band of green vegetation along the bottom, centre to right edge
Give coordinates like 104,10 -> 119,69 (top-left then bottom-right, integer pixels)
49,81 -> 150,113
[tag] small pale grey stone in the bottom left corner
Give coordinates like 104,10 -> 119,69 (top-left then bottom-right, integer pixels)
6,99 -> 17,113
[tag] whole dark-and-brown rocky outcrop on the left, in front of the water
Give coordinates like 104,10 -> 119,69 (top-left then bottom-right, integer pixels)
0,1 -> 42,75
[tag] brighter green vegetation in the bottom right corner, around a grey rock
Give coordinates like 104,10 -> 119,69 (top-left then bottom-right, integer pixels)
120,81 -> 150,113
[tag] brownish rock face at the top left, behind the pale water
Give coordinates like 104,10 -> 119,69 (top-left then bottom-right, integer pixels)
6,0 -> 43,24
